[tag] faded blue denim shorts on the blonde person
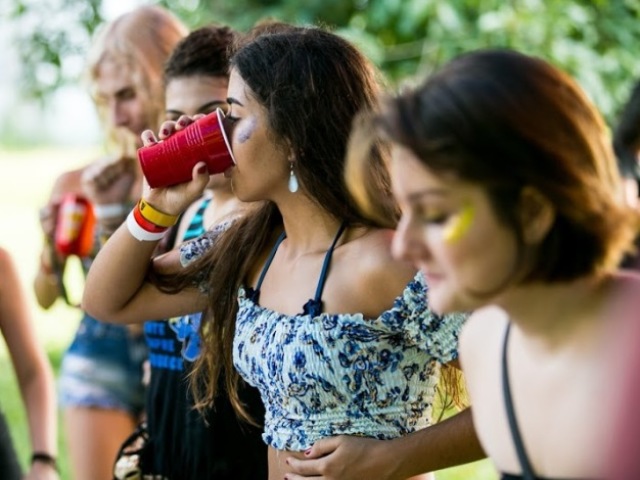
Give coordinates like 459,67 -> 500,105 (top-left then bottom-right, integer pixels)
58,314 -> 147,415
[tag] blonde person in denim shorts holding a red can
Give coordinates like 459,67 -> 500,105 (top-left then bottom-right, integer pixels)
34,6 -> 187,480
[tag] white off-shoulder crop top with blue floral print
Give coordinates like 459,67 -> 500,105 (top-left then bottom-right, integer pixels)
182,227 -> 467,451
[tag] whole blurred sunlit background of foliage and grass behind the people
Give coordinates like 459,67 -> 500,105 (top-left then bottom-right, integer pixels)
0,0 -> 640,480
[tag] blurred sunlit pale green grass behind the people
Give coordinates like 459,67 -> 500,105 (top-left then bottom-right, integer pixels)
0,147 -> 497,480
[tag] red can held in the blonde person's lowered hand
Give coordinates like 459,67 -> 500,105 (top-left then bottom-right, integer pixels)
54,193 -> 96,257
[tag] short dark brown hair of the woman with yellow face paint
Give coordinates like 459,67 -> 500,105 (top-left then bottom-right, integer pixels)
348,50 -> 638,282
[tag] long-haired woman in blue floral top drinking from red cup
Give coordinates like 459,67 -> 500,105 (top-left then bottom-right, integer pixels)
83,26 -> 482,480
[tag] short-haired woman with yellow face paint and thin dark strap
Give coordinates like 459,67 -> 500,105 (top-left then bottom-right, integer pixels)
348,50 -> 640,479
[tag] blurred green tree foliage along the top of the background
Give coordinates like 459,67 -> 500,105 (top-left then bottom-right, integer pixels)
12,0 -> 640,119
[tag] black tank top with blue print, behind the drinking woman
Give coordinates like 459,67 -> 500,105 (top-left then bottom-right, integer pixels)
145,199 -> 268,480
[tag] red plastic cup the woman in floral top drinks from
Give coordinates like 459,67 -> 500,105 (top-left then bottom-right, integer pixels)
138,108 -> 235,188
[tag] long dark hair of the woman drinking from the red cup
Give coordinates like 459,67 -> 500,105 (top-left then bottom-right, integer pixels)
156,23 -> 397,421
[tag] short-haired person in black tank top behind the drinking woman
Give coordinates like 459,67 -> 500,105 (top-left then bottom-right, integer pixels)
134,25 -> 267,480
